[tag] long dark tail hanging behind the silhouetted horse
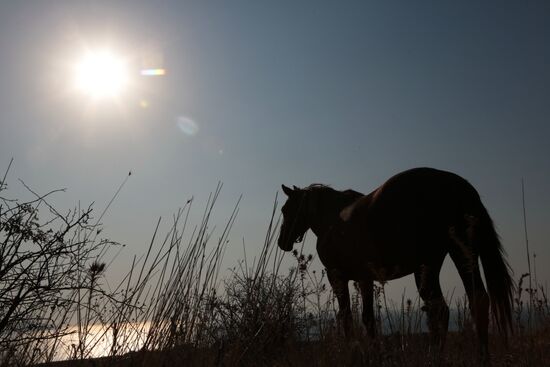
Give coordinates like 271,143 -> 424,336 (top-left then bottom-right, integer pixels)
473,202 -> 514,336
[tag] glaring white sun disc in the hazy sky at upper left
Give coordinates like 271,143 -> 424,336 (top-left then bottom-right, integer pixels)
75,50 -> 128,98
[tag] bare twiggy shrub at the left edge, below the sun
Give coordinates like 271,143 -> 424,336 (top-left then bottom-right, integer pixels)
0,163 -> 120,364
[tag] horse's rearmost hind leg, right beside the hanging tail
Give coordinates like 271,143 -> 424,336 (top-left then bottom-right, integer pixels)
450,231 -> 489,364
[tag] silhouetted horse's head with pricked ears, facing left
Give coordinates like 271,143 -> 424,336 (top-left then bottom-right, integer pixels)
278,185 -> 310,251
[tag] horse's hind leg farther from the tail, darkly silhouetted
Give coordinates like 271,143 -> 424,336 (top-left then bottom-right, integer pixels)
414,260 -> 449,353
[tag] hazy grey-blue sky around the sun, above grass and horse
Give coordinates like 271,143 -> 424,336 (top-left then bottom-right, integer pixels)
0,0 -> 550,297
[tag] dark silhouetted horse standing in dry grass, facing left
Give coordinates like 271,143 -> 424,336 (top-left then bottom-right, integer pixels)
278,167 -> 514,362
